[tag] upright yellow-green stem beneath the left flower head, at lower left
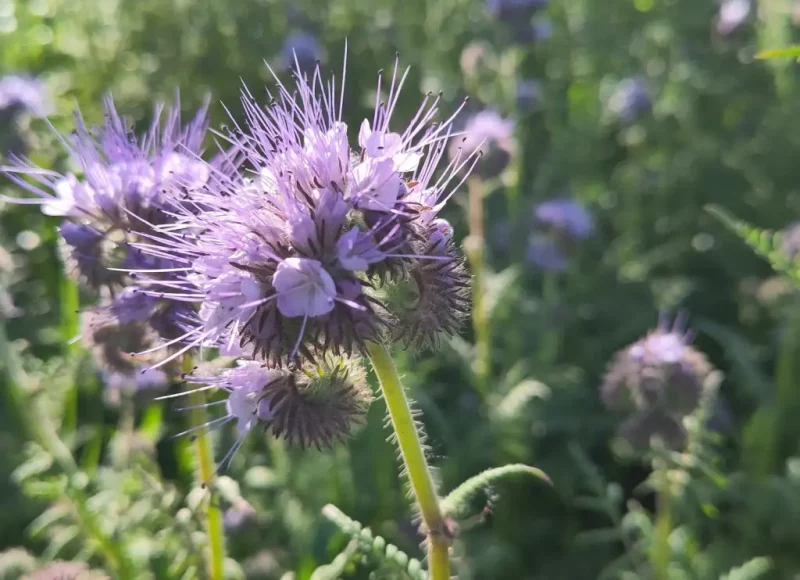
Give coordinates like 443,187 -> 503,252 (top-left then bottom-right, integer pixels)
183,355 -> 225,580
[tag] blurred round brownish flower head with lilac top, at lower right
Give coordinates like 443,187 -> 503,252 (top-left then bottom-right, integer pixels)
600,317 -> 717,450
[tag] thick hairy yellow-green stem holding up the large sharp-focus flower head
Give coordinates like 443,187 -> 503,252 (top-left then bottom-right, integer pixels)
367,343 -> 450,580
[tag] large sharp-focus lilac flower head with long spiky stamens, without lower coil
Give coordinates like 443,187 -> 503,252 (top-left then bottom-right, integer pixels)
135,56 -> 477,367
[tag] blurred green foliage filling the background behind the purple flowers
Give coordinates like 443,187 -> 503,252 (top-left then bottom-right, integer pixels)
0,0 -> 800,580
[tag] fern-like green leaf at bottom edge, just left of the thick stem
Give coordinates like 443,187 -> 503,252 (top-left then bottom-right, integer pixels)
320,504 -> 428,580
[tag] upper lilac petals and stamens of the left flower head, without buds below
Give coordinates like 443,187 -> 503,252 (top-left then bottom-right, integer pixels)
5,97 -> 209,223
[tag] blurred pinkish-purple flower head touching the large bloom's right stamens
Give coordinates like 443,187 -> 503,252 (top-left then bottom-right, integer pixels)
449,109 -> 516,177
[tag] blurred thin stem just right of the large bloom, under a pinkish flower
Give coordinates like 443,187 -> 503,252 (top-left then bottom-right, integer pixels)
465,177 -> 492,394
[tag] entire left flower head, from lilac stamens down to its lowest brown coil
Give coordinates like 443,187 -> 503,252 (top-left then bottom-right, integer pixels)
4,97 -> 210,388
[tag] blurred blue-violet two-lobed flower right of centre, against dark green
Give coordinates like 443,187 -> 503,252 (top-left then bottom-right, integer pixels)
528,198 -> 594,272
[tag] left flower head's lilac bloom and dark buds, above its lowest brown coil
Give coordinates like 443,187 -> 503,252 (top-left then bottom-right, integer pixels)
2,97 -> 216,354
